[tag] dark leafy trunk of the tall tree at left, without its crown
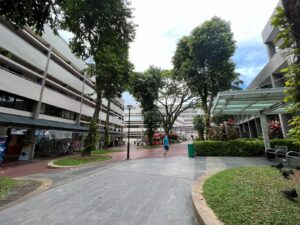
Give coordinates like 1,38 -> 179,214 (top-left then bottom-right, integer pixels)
81,89 -> 102,156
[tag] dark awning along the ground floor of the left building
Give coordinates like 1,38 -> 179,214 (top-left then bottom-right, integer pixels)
0,113 -> 89,132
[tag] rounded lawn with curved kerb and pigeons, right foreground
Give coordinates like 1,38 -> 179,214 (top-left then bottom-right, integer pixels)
203,166 -> 300,225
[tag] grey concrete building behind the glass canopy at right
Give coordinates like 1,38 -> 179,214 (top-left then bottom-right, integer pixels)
231,1 -> 291,138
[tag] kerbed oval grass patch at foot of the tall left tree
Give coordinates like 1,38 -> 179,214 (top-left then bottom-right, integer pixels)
53,155 -> 112,166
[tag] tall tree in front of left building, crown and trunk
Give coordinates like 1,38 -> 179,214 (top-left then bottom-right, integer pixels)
61,0 -> 135,155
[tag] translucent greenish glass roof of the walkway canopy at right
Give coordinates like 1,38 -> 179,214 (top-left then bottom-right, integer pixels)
211,88 -> 287,115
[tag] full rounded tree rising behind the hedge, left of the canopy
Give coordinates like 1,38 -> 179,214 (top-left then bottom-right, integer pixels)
173,17 -> 238,131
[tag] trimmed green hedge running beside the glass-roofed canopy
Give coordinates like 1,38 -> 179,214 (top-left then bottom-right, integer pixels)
194,139 -> 299,156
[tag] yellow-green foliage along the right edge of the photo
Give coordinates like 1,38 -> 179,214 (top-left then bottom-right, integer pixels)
272,0 -> 300,146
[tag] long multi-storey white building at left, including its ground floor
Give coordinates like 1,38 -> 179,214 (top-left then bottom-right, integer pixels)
0,20 -> 124,162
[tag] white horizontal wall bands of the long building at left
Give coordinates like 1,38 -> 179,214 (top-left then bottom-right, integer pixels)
0,20 -> 124,135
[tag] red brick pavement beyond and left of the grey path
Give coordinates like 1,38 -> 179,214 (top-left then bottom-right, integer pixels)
0,142 -> 188,177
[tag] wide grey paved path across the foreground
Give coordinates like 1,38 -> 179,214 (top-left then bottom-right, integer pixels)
0,157 -> 269,225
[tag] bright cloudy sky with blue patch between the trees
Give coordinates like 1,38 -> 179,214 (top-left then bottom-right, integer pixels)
61,0 -> 278,105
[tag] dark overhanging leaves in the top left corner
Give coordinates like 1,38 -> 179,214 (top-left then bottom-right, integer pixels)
0,0 -> 64,35
